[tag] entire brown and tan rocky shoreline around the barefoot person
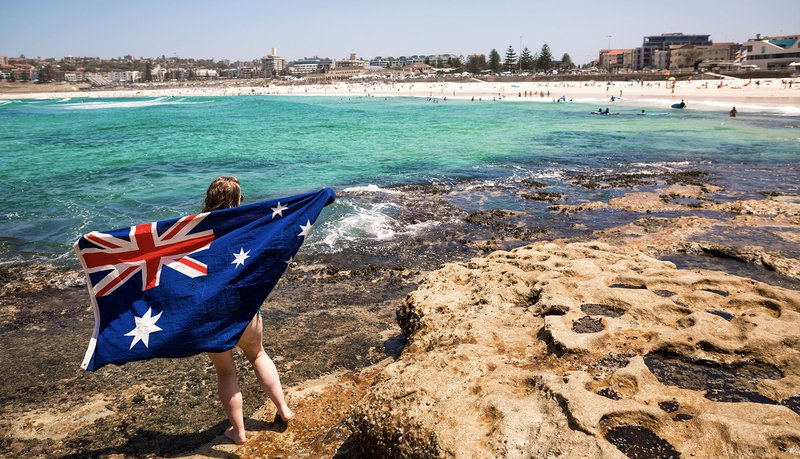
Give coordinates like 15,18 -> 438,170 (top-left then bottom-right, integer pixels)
0,173 -> 800,457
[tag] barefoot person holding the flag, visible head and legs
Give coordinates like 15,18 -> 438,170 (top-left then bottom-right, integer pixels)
203,177 -> 293,445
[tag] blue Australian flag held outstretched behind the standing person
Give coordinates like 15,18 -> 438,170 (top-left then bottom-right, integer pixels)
73,188 -> 336,371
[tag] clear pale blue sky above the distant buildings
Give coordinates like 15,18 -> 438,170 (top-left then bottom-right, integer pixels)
0,0 -> 800,64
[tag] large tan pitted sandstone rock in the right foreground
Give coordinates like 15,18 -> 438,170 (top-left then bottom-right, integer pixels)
350,243 -> 800,457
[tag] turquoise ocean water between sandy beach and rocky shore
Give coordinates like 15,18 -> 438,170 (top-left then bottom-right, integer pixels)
0,96 -> 800,263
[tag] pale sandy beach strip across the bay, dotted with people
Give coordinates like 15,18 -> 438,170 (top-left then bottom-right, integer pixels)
0,75 -> 800,115
